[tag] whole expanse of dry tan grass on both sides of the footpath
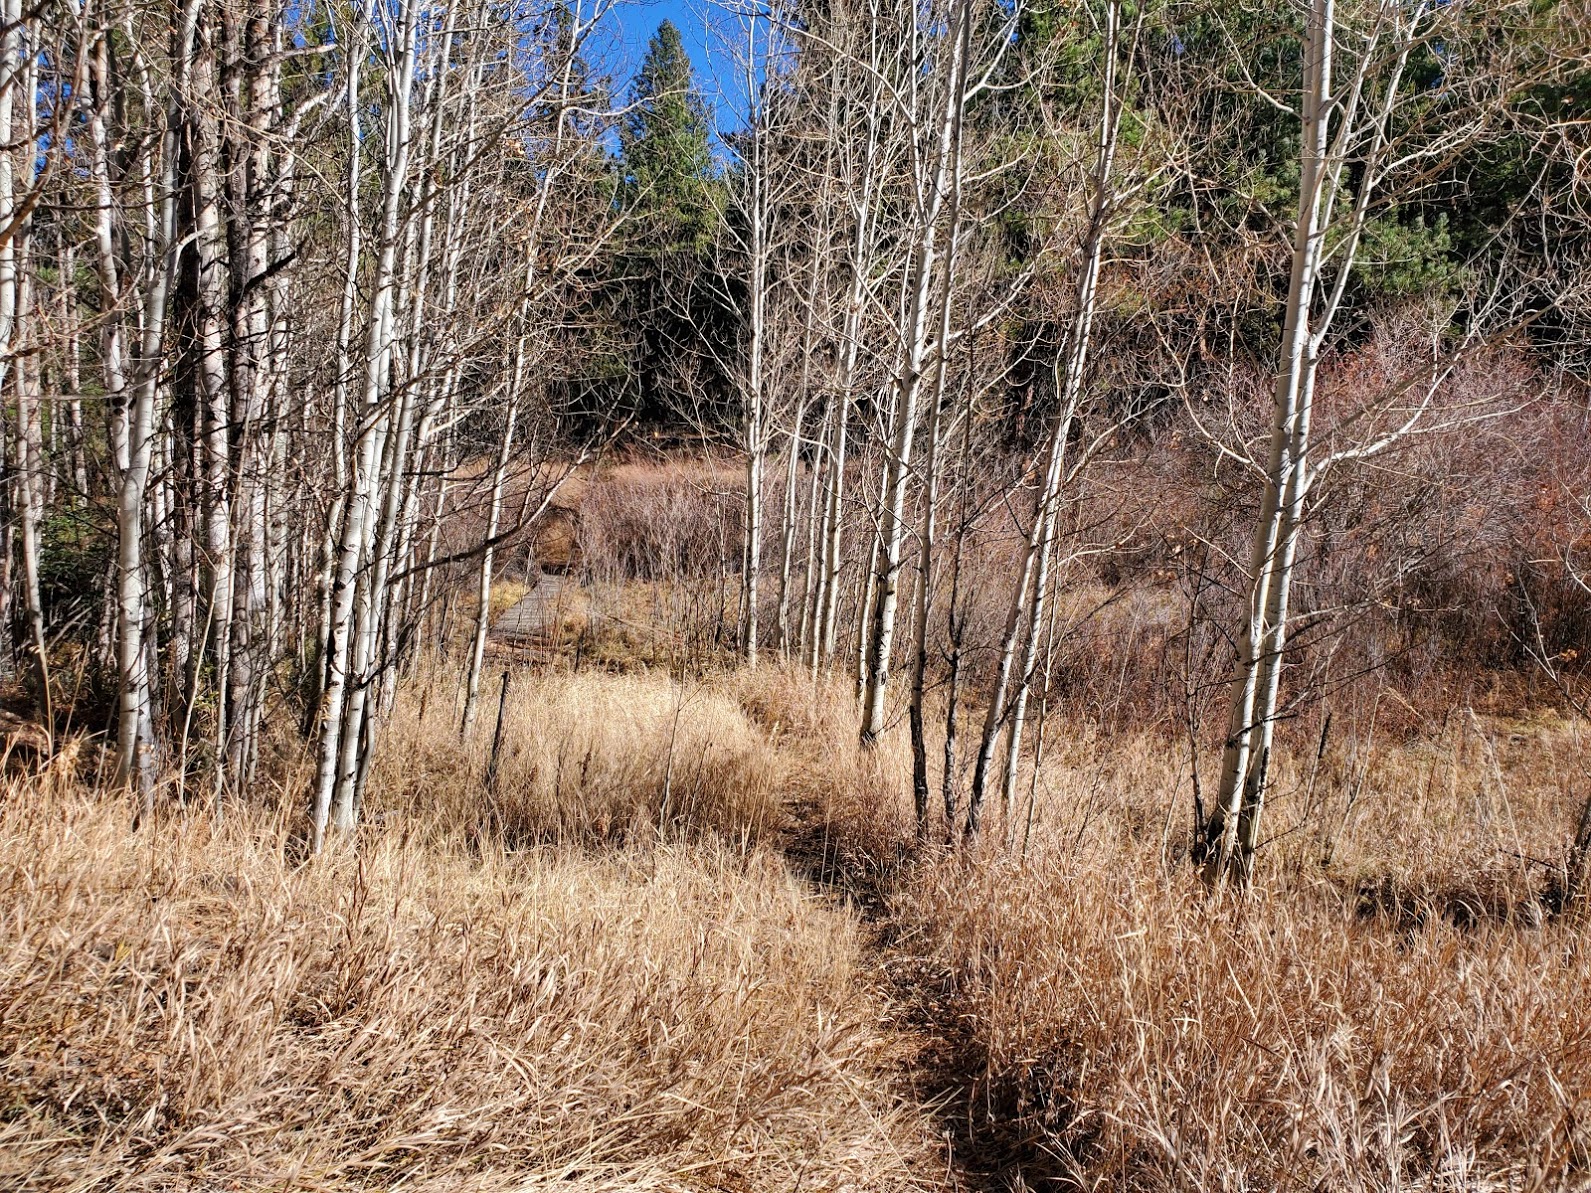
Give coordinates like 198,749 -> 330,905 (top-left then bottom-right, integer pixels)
0,663 -> 1591,1190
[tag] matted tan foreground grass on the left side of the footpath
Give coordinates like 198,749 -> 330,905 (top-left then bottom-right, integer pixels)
0,769 -> 923,1191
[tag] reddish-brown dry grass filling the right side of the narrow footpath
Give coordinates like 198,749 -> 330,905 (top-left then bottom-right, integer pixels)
893,730 -> 1591,1190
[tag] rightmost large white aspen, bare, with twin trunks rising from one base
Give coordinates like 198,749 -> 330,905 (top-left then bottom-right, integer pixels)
1198,0 -> 1546,886
